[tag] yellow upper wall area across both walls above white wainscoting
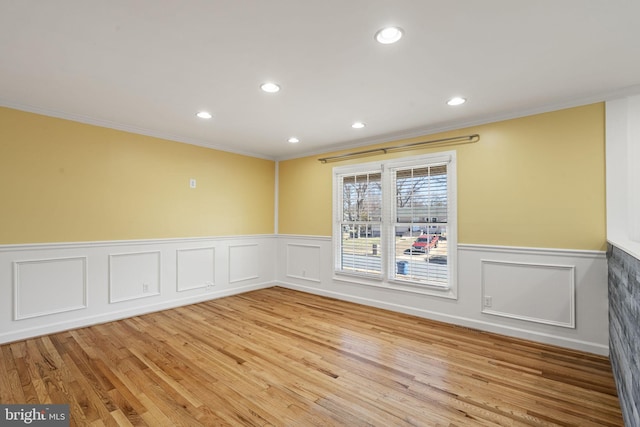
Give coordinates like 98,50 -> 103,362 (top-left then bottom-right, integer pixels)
0,104 -> 606,250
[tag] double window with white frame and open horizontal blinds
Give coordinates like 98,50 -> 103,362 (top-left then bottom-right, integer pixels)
333,151 -> 456,298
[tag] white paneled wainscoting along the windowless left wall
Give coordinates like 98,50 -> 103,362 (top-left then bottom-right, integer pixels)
0,235 -> 277,343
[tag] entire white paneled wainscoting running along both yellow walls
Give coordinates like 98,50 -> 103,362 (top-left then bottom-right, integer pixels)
0,235 -> 608,355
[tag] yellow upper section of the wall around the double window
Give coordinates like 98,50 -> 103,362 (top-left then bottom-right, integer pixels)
278,104 -> 606,250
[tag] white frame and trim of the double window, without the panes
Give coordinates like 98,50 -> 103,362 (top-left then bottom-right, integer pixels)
332,150 -> 458,299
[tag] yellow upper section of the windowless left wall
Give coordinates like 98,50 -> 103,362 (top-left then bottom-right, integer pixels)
0,108 -> 275,244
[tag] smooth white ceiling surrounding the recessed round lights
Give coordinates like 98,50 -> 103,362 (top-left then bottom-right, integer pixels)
0,0 -> 640,159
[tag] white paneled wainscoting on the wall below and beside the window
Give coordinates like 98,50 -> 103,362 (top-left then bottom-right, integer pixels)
276,235 -> 609,356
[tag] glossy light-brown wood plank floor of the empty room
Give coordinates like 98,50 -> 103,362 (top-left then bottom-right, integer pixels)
0,287 -> 622,427
